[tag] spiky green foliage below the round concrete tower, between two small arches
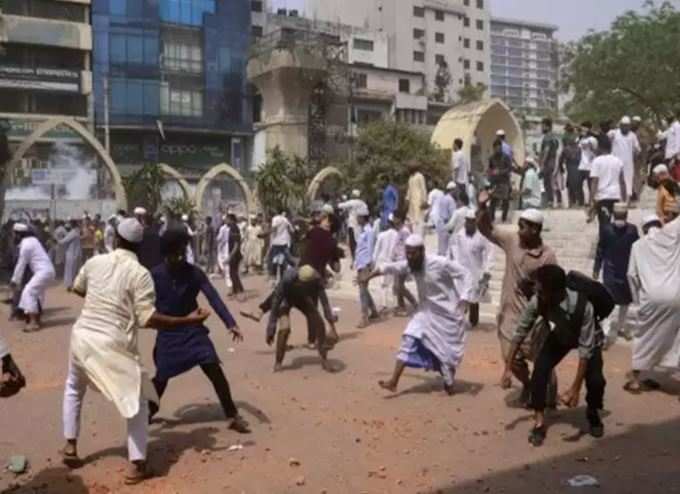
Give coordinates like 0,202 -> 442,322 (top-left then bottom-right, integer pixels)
255,147 -> 318,218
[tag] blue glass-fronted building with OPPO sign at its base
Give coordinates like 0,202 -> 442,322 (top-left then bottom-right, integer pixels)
92,0 -> 252,168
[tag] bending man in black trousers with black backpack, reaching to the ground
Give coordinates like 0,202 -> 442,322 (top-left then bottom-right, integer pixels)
501,265 -> 607,446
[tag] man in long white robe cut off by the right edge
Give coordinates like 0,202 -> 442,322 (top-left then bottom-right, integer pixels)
626,214 -> 680,393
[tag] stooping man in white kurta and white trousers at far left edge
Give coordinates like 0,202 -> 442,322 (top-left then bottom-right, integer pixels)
11,223 -> 55,332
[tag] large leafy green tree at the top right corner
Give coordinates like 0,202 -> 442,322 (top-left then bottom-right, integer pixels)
561,1 -> 680,122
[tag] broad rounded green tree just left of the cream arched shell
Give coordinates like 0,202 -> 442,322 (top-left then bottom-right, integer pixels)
339,121 -> 450,212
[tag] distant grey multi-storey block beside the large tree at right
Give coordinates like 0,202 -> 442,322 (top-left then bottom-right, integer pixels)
491,18 -> 559,116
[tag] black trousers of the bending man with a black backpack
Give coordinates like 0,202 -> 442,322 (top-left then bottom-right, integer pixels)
531,332 -> 607,412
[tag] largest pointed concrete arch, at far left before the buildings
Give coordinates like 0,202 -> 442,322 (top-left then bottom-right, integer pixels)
7,117 -> 127,209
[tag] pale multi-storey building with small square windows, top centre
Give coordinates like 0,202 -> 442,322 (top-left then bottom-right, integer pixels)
306,0 -> 490,102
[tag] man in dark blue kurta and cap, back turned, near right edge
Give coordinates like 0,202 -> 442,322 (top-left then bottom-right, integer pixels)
593,203 -> 640,347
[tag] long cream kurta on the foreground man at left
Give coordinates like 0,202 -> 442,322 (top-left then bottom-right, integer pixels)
71,249 -> 157,418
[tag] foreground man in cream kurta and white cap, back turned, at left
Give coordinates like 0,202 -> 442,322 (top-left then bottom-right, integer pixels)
62,218 -> 210,483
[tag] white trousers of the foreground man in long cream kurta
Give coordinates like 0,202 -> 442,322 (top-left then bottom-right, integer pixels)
64,363 -> 149,461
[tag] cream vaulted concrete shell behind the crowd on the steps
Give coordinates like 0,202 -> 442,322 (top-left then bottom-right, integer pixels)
432,99 -> 526,171
